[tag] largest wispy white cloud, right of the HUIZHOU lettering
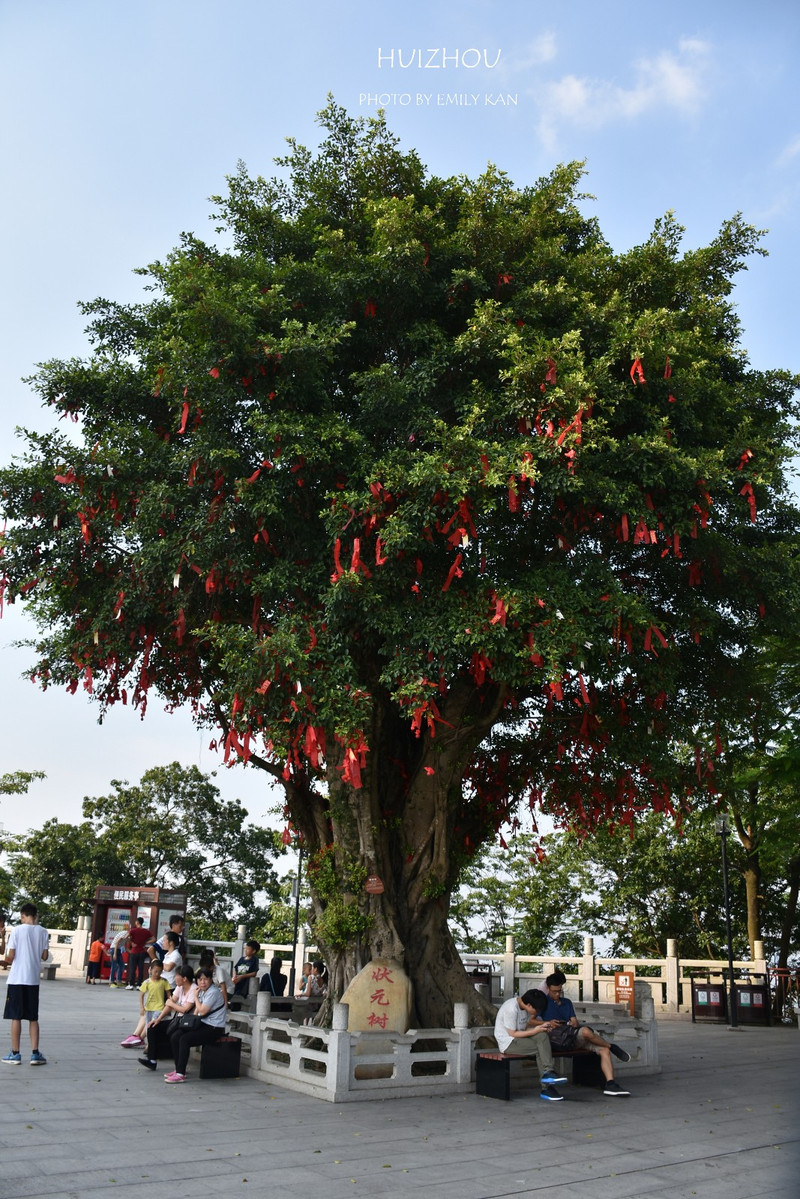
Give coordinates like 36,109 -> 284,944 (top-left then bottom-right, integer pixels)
537,38 -> 709,146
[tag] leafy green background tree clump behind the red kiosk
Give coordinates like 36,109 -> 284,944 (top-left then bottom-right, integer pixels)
5,763 -> 282,938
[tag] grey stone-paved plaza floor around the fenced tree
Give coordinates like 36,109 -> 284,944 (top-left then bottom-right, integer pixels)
0,978 -> 800,1199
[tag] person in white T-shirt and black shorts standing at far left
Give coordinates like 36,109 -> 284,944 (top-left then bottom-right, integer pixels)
2,903 -> 50,1066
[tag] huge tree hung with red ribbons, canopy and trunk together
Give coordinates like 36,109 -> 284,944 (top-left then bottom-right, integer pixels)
0,103 -> 796,1026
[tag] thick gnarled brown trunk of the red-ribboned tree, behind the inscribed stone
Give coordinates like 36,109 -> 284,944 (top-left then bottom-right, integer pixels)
288,687 -> 499,1028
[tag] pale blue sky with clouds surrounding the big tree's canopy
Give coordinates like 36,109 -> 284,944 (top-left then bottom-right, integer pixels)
0,0 -> 800,831
